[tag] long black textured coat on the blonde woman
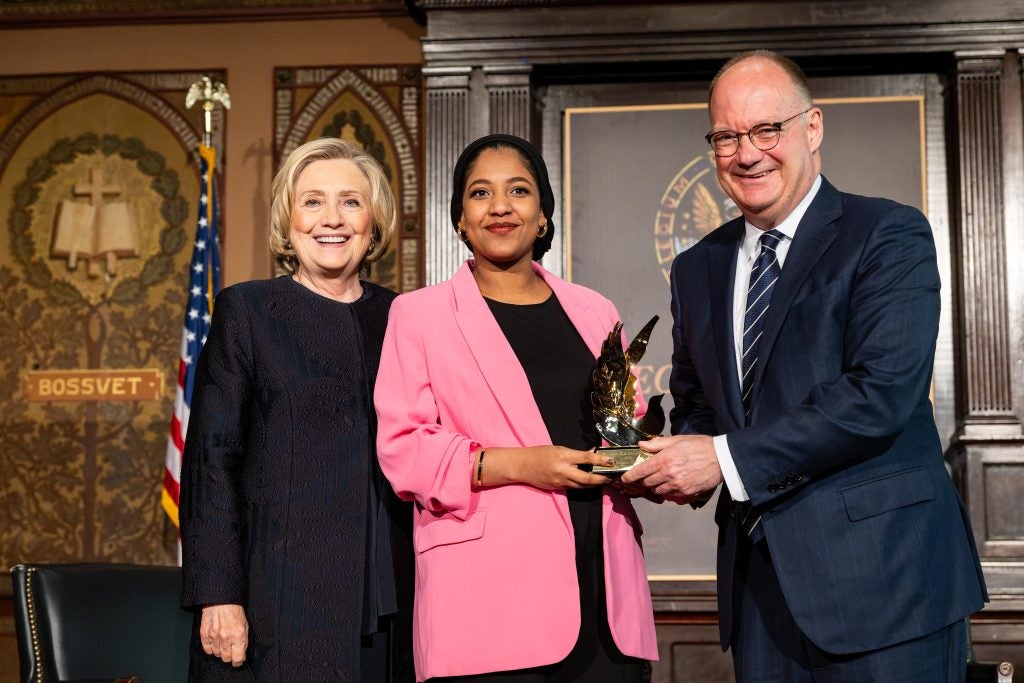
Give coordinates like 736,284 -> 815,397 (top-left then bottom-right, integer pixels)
180,278 -> 413,681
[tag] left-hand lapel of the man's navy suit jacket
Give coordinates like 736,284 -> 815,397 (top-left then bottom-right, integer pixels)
708,218 -> 743,427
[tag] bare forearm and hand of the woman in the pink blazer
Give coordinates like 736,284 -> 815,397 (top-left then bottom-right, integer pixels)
481,445 -> 612,490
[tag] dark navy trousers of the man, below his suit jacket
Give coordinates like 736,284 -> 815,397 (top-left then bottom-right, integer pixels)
731,537 -> 967,683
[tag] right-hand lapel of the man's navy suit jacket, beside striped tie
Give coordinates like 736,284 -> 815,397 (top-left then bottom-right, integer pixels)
752,176 -> 843,404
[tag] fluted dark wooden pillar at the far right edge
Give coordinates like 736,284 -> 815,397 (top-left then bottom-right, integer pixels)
949,50 -> 1024,593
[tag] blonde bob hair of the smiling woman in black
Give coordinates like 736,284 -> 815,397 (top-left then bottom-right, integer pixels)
270,137 -> 398,275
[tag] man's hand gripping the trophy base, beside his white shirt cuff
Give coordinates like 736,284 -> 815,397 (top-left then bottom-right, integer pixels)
623,435 -> 722,505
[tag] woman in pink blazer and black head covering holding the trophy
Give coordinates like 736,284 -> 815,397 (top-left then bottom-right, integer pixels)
375,135 -> 657,683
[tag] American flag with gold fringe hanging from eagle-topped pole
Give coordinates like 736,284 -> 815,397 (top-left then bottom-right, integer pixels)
161,145 -> 220,526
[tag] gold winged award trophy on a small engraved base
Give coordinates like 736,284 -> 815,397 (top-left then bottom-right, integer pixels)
591,315 -> 665,477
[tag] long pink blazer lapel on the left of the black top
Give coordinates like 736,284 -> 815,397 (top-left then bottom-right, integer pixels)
452,261 -> 551,445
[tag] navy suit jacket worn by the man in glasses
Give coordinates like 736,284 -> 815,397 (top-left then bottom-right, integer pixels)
671,178 -> 987,653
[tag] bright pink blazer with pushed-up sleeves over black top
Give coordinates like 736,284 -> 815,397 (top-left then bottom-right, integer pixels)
375,261 -> 657,681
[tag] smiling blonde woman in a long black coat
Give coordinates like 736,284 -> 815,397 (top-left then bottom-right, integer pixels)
180,138 -> 412,682
